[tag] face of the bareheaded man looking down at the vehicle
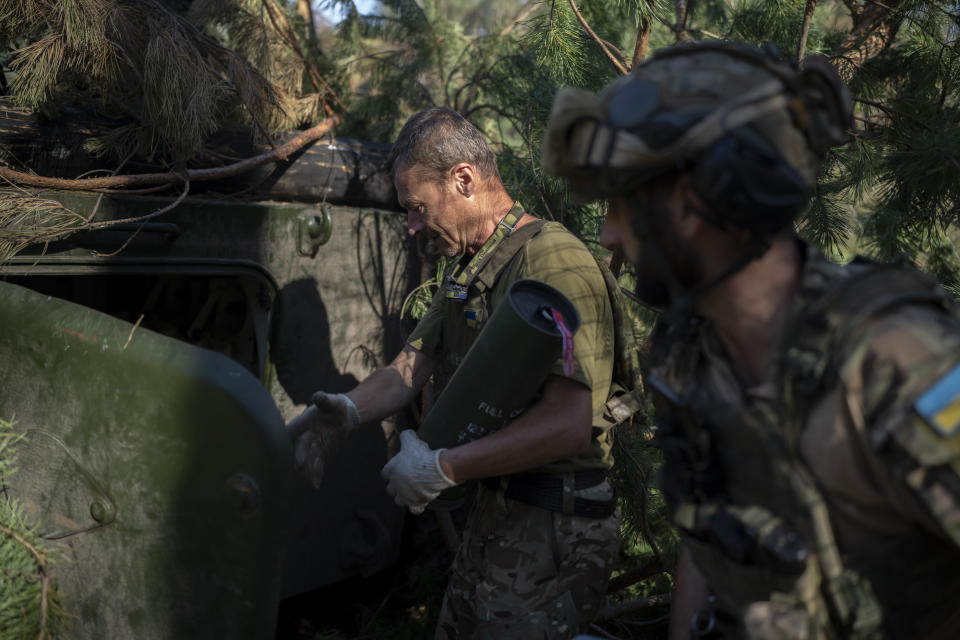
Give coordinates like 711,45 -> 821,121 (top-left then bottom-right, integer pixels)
393,167 -> 466,257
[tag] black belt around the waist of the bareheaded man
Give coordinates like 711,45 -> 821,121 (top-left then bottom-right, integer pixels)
480,469 -> 617,518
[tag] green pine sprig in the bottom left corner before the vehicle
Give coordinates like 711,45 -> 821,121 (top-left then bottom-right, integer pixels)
0,419 -> 68,640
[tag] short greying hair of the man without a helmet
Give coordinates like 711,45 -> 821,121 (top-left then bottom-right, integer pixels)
388,107 -> 501,182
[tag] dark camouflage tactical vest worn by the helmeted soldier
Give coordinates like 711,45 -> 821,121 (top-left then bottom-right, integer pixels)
648,252 -> 955,640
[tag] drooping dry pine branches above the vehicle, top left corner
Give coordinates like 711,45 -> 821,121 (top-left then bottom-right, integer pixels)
0,0 -> 338,164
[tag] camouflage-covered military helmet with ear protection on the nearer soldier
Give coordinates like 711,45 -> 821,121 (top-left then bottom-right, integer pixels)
542,41 -> 852,232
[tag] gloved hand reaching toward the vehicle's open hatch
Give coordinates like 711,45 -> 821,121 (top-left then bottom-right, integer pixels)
287,391 -> 360,488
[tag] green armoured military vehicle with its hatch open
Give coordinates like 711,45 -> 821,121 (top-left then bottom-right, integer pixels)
0,115 -> 420,639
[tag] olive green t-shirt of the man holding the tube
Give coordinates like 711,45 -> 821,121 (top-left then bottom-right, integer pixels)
407,222 -> 614,472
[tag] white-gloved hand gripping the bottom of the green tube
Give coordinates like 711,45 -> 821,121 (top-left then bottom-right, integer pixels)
380,429 -> 457,514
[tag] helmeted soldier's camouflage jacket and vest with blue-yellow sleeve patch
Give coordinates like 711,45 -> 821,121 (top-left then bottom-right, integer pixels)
648,242 -> 960,639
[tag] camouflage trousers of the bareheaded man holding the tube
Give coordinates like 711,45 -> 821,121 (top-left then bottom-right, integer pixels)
436,483 -> 620,640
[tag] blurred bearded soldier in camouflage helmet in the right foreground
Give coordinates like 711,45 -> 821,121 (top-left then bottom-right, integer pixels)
543,43 -> 960,639
